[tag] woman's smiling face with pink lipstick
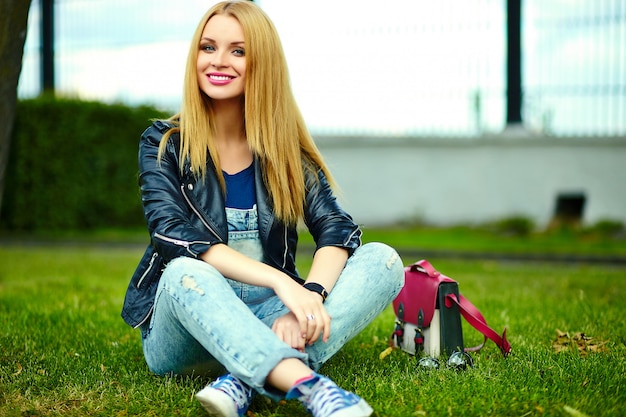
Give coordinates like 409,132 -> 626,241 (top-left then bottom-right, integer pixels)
197,15 -> 246,100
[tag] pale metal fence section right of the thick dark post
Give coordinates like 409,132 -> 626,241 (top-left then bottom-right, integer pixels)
523,0 -> 626,136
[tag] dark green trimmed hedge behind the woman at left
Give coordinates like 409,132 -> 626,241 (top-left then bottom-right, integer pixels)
0,97 -> 167,231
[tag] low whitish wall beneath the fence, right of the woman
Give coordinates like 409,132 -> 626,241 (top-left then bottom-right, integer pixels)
316,132 -> 626,227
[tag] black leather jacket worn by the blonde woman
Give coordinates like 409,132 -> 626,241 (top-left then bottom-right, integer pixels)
122,121 -> 361,327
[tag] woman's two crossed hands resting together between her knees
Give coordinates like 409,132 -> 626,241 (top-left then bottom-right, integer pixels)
272,280 -> 331,351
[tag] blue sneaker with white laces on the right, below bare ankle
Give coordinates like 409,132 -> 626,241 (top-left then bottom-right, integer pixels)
286,374 -> 374,417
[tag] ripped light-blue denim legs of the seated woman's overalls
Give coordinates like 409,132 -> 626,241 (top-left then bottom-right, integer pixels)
141,237 -> 404,399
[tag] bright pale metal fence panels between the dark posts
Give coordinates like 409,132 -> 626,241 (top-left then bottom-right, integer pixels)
18,0 -> 626,137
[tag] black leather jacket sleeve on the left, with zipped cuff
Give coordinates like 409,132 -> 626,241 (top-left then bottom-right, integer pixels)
139,122 -> 222,263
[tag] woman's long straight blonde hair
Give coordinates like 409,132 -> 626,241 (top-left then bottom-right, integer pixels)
159,1 -> 335,224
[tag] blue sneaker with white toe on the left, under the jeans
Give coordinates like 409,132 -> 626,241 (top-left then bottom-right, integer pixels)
196,374 -> 254,417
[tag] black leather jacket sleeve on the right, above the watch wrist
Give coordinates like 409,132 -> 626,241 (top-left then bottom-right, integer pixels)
304,170 -> 361,256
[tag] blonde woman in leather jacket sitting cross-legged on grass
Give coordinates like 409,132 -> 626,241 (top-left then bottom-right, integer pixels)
122,1 -> 403,417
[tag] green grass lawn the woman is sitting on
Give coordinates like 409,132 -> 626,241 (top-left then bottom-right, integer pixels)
0,231 -> 626,417
